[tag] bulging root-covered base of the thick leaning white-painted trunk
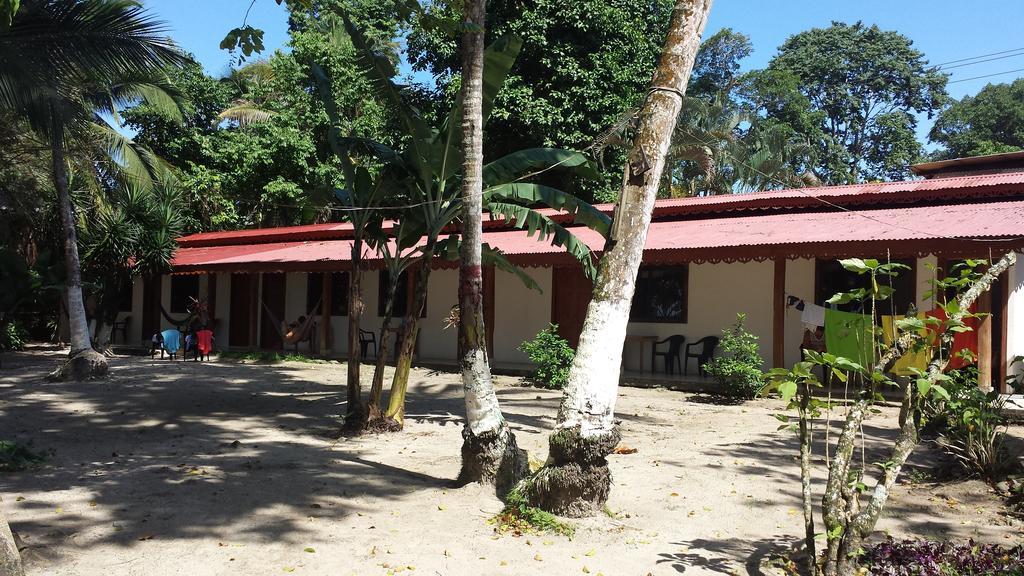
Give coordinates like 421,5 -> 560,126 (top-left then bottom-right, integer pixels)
524,426 -> 622,518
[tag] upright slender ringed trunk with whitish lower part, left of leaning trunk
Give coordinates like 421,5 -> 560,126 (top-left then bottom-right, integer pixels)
459,0 -> 529,494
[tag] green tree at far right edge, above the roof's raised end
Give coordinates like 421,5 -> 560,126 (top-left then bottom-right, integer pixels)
928,78 -> 1024,159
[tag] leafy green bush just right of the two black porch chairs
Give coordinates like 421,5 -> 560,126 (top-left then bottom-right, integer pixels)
703,314 -> 764,399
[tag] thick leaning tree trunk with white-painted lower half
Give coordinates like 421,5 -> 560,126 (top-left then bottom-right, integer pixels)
524,0 -> 712,516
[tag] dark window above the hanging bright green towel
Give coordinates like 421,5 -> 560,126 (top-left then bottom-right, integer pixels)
814,258 -> 918,315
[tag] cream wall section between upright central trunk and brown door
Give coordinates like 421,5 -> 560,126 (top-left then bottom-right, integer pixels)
494,268 -> 552,365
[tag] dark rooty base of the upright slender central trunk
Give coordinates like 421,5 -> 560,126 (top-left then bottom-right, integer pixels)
456,423 -> 529,497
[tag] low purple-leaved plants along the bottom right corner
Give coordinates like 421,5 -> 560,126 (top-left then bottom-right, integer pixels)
863,538 -> 1024,576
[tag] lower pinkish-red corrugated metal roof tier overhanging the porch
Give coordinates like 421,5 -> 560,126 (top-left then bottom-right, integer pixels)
173,200 -> 1024,272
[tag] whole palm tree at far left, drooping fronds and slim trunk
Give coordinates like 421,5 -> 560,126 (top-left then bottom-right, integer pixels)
0,0 -> 186,378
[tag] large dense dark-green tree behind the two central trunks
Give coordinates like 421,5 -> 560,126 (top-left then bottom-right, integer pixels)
409,0 -> 674,200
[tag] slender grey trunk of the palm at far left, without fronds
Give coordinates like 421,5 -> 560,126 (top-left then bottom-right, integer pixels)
50,123 -> 106,380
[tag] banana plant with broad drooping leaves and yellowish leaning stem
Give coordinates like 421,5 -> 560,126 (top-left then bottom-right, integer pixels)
313,20 -> 610,426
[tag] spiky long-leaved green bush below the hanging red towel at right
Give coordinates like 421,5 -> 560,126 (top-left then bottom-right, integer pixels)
924,366 -> 1013,481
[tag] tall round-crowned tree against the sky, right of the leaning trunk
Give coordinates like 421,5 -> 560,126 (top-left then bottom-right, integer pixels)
741,22 -> 948,183
